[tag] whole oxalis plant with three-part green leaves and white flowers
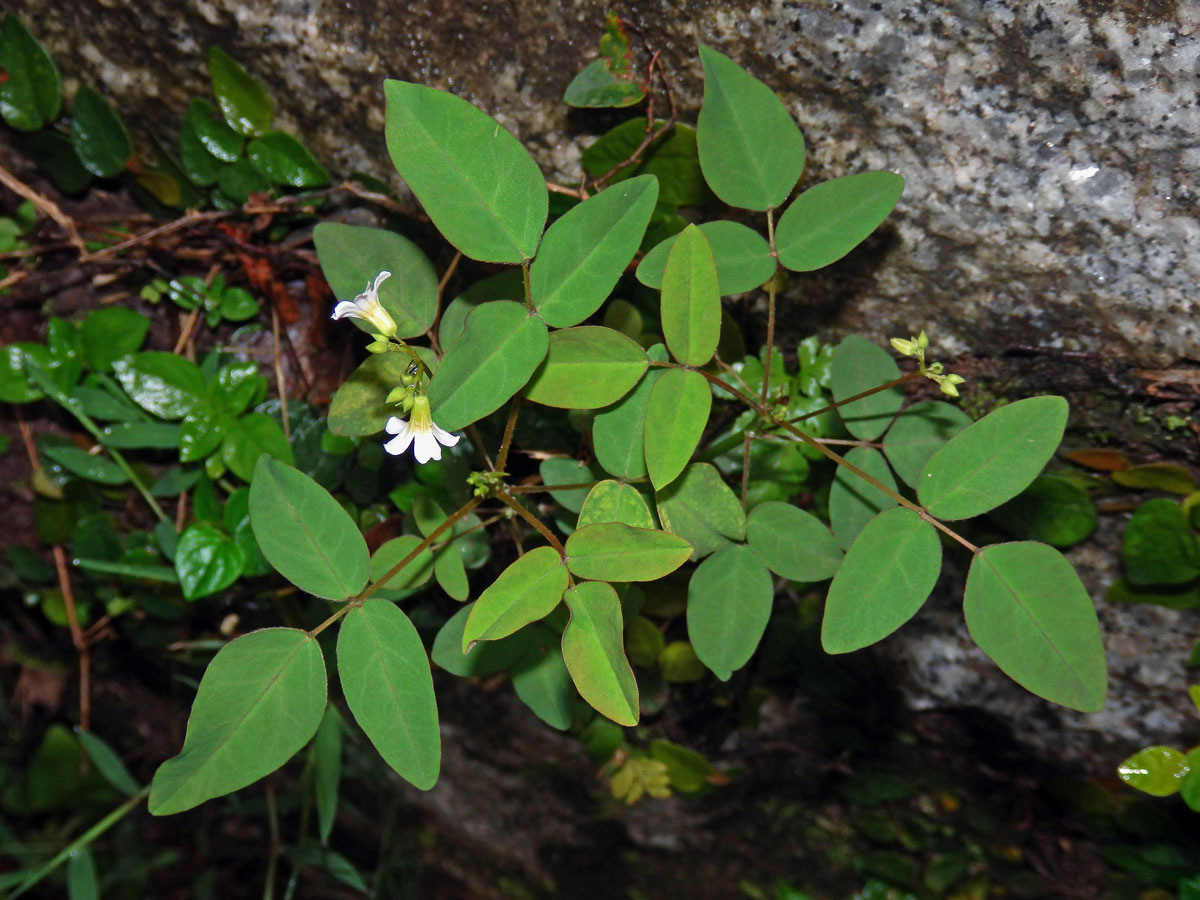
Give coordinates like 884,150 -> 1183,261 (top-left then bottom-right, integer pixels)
142,47 -> 1106,815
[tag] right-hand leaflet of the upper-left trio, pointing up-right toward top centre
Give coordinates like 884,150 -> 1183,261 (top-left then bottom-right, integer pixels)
529,175 -> 659,328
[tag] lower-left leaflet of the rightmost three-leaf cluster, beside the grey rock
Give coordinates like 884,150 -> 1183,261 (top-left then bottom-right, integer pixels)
821,509 -> 942,653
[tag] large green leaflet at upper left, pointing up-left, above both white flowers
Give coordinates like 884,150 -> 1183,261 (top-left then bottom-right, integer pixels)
384,80 -> 550,263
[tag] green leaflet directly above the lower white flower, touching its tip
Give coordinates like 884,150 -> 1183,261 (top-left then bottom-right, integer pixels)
428,300 -> 550,431
